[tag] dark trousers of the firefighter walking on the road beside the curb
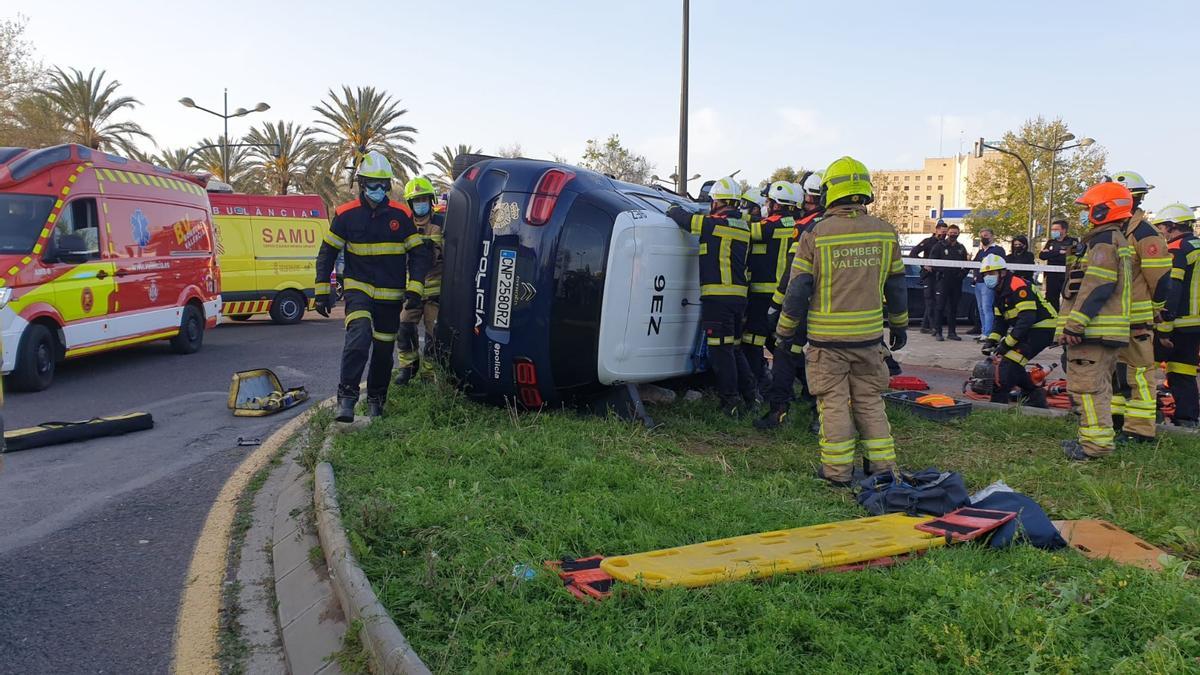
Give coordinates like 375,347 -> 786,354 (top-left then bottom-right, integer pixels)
337,291 -> 401,400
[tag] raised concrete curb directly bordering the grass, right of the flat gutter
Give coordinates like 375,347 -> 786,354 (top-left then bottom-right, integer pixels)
313,418 -> 430,675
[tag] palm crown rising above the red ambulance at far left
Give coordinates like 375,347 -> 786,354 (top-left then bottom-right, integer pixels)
38,67 -> 154,154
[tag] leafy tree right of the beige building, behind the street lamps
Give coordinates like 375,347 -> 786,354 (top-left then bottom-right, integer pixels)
967,117 -> 1108,238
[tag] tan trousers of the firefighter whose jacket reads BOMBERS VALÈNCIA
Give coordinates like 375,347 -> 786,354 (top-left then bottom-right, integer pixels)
804,345 -> 896,480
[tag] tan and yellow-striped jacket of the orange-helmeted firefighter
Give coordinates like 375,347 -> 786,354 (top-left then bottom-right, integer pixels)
1057,223 -> 1133,347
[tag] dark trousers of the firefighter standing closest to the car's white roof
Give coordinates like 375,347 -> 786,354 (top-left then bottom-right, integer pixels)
700,298 -> 758,407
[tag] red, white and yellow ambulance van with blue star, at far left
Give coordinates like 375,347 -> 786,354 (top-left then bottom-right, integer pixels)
0,144 -> 221,392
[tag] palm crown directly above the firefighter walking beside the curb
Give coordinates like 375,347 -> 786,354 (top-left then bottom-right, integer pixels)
312,85 -> 421,186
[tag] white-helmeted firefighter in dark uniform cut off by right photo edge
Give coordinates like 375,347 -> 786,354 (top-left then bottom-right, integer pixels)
1154,203 -> 1200,428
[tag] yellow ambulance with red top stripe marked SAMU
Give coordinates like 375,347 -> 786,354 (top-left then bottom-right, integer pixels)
209,192 -> 329,324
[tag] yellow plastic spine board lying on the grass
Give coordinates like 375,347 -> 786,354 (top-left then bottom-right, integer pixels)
600,513 -> 946,587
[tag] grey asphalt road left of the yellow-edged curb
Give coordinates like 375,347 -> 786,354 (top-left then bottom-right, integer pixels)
0,313 -> 343,675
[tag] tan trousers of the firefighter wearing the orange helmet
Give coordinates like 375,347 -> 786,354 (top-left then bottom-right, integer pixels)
1067,342 -> 1121,456
